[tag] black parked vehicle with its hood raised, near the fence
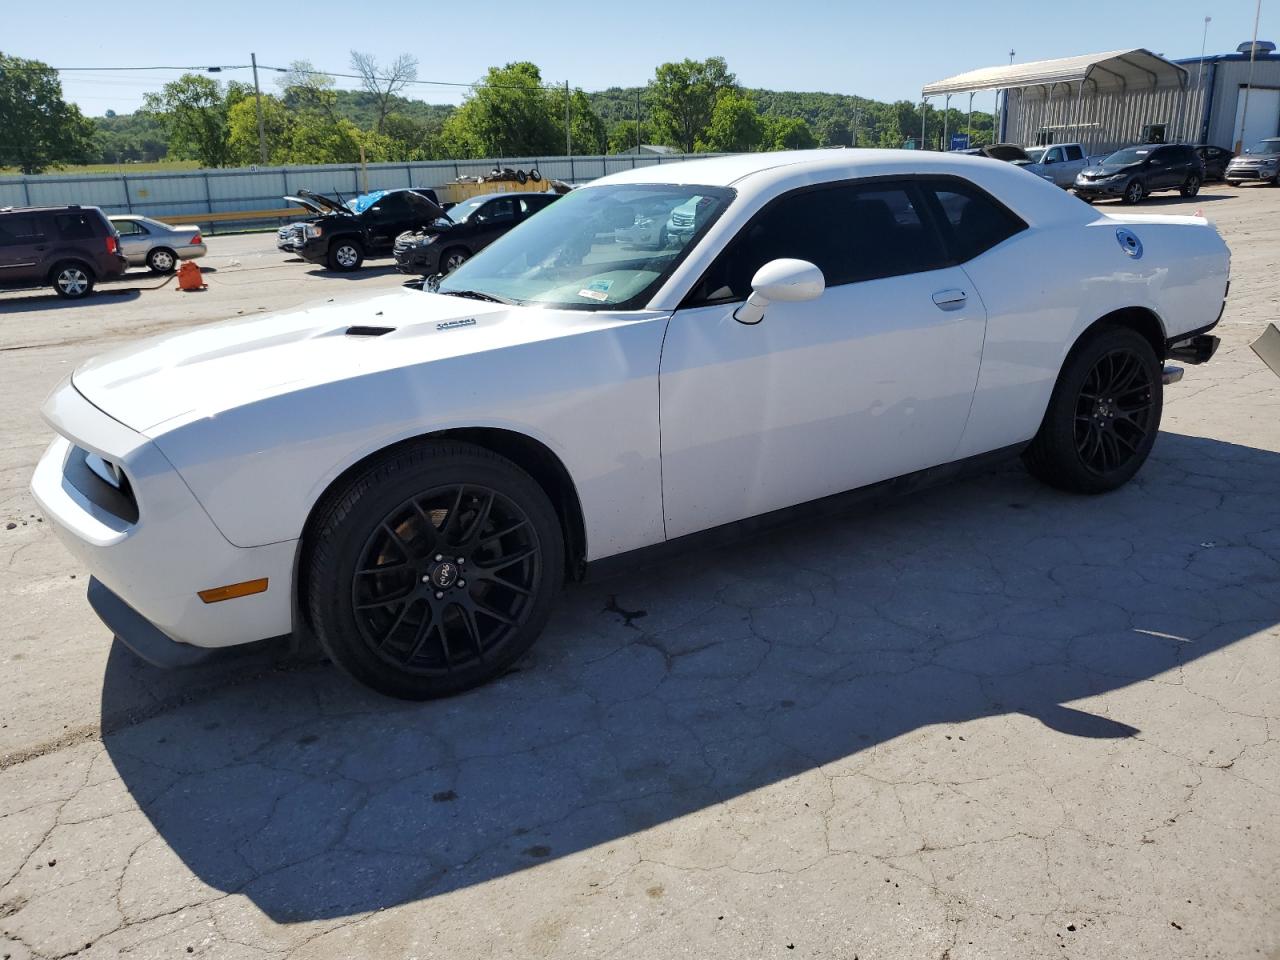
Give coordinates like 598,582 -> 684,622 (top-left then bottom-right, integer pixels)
275,188 -> 444,270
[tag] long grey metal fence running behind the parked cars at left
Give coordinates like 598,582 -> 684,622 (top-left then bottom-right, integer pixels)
0,154 -> 716,229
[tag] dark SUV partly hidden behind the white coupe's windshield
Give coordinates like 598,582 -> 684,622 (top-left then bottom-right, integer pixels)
396,192 -> 558,276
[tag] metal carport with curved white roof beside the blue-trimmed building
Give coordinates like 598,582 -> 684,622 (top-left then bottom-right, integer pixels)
920,47 -> 1199,154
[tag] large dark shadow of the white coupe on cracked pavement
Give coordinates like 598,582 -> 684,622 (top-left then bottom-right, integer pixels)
102,434 -> 1280,923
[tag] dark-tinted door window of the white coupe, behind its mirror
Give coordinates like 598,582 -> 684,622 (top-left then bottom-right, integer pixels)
689,183 -> 947,303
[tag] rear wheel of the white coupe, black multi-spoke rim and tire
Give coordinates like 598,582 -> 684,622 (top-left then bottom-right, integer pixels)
1023,326 -> 1164,494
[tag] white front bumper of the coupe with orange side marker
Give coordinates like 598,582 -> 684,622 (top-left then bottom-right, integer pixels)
31,381 -> 297,655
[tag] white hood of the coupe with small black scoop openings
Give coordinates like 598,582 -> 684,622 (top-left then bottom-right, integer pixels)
72,289 -> 645,436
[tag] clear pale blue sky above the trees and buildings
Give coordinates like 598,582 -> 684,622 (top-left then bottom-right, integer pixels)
0,0 -> 1259,115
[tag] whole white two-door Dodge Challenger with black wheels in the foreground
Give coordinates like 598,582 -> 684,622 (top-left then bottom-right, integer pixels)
32,150 -> 1230,698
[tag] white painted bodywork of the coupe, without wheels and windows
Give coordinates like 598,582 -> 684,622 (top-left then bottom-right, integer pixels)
32,150 -> 1229,660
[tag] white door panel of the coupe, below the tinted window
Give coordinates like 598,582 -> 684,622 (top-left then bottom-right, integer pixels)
662,266 -> 986,536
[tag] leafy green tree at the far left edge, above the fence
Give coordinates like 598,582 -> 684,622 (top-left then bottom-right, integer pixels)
0,52 -> 93,173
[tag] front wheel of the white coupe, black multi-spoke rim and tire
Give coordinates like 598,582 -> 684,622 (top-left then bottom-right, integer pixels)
305,443 -> 564,700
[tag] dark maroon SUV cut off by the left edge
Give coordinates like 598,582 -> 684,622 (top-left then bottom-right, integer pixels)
0,206 -> 128,300
